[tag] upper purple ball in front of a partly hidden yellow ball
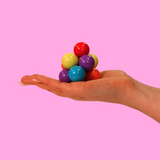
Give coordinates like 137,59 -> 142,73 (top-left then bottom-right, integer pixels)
79,55 -> 95,72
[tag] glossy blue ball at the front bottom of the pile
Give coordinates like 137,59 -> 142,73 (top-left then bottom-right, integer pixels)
68,66 -> 86,82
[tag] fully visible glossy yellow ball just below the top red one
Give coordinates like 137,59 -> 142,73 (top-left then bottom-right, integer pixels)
62,53 -> 78,69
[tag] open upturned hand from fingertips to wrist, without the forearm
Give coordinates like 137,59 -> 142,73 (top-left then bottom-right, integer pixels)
21,70 -> 135,104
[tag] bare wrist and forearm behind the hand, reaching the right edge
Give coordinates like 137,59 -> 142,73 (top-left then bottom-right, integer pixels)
125,79 -> 160,123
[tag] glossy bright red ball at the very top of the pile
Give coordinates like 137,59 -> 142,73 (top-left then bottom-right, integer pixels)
74,42 -> 90,57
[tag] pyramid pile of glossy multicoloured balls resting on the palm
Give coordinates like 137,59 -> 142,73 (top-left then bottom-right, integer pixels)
59,42 -> 100,83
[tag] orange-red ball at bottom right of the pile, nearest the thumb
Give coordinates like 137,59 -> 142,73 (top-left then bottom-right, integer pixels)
85,68 -> 101,81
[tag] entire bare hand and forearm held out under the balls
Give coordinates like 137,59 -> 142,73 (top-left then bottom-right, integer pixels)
21,70 -> 160,123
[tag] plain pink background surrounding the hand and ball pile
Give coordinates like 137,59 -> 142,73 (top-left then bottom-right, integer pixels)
0,0 -> 160,160
